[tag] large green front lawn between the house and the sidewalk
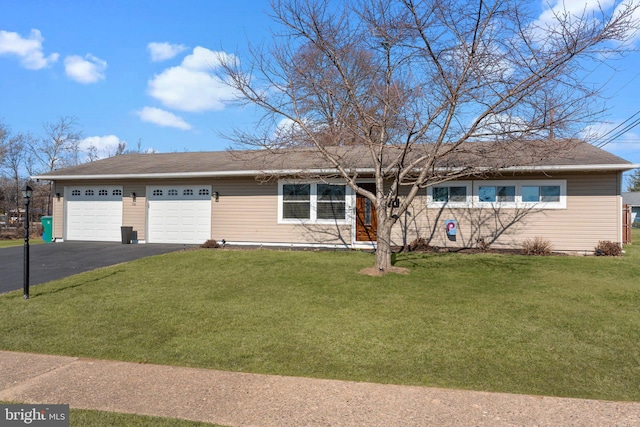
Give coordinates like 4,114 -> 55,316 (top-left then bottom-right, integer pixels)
0,239 -> 640,401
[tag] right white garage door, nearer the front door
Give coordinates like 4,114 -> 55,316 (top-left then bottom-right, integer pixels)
147,185 -> 211,244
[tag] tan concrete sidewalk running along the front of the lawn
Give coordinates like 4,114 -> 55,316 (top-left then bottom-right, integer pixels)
0,352 -> 640,427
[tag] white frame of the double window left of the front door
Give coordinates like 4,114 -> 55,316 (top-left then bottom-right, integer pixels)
278,179 -> 353,225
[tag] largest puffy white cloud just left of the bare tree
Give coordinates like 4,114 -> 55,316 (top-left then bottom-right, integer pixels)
148,46 -> 234,112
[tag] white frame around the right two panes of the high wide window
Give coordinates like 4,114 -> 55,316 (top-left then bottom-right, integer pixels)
473,179 -> 567,209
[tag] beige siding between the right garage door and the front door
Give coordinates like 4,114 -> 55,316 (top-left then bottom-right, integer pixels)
211,178 -> 351,245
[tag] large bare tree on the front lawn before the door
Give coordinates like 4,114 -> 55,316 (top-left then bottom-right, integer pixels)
219,0 -> 638,271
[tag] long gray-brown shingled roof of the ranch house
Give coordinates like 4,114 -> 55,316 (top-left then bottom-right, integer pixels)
34,140 -> 637,180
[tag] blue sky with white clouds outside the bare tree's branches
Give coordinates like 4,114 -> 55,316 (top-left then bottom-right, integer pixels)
0,0 -> 640,169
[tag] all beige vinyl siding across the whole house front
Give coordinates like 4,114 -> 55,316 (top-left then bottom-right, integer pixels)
53,172 -> 621,253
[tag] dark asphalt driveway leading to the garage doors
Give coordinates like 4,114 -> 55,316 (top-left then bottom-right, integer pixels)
0,242 -> 193,293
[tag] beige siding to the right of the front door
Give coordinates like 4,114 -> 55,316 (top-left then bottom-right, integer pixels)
393,173 -> 621,253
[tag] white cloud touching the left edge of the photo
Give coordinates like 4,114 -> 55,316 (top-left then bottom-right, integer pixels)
0,30 -> 60,70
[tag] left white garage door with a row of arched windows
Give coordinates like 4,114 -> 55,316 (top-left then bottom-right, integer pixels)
65,186 -> 122,242
